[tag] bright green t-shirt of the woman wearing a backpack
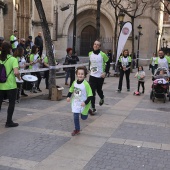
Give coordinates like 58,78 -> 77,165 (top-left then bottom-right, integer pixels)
0,55 -> 18,90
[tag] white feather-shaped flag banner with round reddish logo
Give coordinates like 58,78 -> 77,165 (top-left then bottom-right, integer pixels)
116,21 -> 132,64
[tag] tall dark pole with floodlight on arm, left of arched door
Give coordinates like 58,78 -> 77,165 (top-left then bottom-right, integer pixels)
60,0 -> 78,54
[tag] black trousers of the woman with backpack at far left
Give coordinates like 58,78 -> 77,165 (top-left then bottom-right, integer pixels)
0,89 -> 17,123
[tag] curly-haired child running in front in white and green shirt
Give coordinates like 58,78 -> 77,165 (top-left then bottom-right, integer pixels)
67,67 -> 92,136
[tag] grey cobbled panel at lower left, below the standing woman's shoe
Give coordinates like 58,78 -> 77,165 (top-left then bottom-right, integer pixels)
0,129 -> 70,161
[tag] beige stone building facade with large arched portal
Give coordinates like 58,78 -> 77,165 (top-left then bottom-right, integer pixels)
0,0 -> 163,61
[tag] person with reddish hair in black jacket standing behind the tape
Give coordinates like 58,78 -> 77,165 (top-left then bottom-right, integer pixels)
65,48 -> 79,87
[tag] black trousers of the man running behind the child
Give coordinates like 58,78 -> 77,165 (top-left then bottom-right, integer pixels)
89,76 -> 104,108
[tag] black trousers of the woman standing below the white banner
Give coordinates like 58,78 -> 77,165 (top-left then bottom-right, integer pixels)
118,69 -> 130,91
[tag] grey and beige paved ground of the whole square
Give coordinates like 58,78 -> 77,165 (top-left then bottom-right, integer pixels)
0,66 -> 170,170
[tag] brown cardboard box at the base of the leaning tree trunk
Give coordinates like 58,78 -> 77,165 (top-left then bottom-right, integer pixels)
51,86 -> 64,101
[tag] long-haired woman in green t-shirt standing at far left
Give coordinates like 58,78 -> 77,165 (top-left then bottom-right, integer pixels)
0,42 -> 20,128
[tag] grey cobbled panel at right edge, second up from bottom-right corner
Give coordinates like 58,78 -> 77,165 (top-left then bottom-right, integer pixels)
112,122 -> 170,144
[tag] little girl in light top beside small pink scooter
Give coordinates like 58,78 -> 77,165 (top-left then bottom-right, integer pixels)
135,66 -> 145,93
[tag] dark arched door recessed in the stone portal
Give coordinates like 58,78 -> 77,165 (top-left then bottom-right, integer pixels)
80,25 -> 96,56
